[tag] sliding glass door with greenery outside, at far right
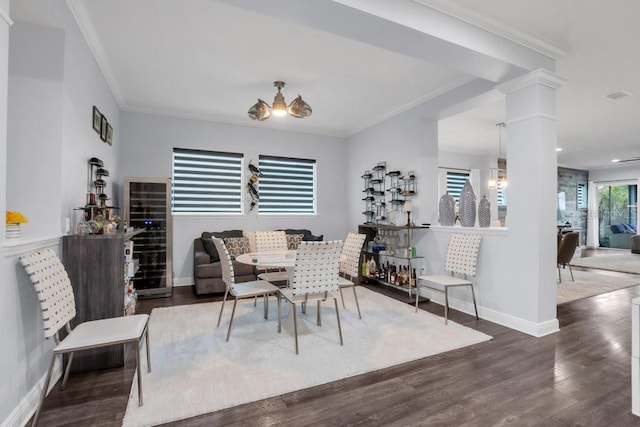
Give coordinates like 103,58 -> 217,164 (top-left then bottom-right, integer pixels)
598,183 -> 638,249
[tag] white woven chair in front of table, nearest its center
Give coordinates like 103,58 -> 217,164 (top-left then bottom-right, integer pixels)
278,240 -> 343,354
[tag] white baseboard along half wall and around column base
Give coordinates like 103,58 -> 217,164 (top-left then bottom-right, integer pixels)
420,288 -> 560,338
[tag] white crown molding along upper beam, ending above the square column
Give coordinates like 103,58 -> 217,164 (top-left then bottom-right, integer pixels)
412,0 -> 565,59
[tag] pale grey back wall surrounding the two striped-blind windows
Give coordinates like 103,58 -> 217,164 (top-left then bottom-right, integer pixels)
118,113 -> 355,285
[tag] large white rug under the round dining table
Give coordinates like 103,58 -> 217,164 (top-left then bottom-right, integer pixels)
123,287 -> 491,427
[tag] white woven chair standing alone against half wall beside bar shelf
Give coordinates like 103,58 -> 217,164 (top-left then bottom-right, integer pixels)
416,233 -> 482,325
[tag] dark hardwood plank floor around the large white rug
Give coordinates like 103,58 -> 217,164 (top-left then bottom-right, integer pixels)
32,278 -> 640,427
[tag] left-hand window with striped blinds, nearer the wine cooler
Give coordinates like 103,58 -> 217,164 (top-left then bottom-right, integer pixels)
172,148 -> 243,214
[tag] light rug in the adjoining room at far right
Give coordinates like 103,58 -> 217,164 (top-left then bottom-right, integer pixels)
556,268 -> 640,304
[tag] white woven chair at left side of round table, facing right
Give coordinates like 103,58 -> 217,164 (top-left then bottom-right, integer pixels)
211,237 -> 278,341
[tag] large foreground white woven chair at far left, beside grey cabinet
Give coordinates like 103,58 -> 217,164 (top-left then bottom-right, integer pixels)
20,249 -> 151,426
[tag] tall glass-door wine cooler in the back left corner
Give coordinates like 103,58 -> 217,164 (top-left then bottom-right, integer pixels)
123,177 -> 173,298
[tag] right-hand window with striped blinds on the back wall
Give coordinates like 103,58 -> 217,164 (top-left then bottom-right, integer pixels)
258,156 -> 316,214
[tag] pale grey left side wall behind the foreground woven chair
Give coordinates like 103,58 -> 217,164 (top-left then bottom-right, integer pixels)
0,2 -> 119,426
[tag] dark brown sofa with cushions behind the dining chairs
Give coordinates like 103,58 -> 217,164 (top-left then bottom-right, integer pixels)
193,229 -> 323,295
